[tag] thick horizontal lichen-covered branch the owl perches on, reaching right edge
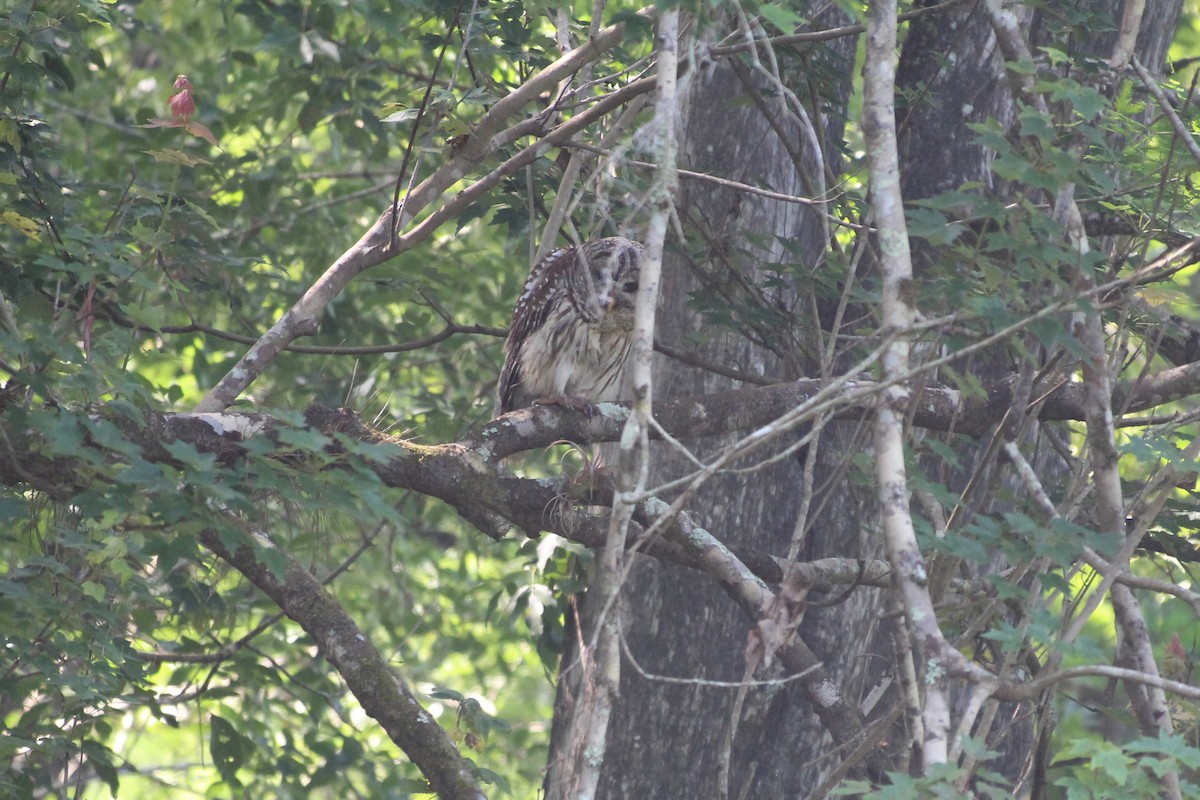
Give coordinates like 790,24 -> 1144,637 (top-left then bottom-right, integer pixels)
14,362 -> 1200,513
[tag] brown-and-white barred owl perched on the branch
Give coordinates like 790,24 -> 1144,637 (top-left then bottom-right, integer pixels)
494,236 -> 642,416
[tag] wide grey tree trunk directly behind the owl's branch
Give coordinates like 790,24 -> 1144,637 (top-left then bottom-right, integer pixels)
547,15 -> 882,798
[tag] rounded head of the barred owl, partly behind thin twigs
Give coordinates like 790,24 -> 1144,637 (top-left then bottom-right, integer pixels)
566,236 -> 643,324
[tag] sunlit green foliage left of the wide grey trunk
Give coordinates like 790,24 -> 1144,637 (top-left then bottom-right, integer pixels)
0,2 -> 595,796
